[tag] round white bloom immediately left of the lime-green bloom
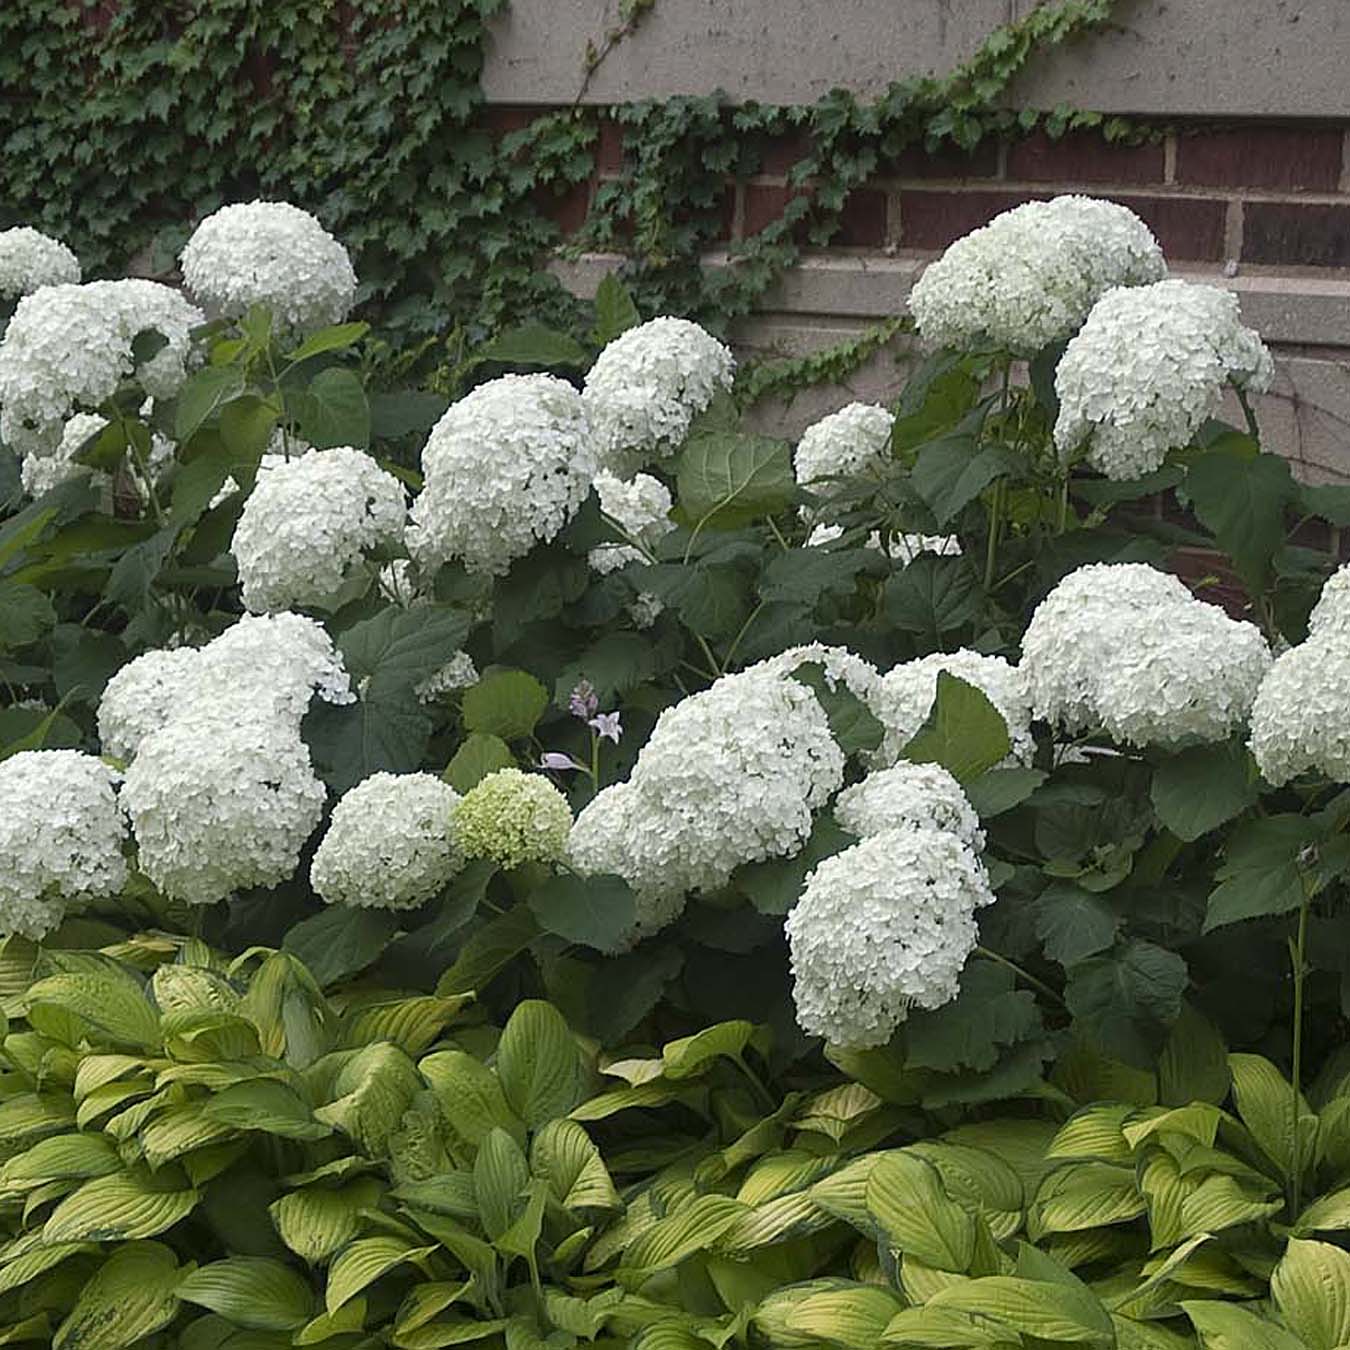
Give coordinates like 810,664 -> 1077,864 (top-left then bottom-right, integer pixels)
309,774 -> 463,910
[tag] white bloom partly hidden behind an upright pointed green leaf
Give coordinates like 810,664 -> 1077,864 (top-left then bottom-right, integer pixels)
873,648 -> 1035,767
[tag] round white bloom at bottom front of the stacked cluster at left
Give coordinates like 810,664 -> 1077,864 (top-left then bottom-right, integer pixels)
122,689 -> 327,905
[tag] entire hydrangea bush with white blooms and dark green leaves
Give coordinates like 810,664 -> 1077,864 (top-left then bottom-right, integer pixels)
0,198 -> 1350,1323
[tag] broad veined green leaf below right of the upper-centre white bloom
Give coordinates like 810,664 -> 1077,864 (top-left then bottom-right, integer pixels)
675,432 -> 797,529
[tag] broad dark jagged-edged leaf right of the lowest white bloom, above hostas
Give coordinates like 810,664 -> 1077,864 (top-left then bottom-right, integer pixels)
1064,938 -> 1189,1069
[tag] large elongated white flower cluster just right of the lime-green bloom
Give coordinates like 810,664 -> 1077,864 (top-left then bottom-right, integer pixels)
568,667 -> 844,934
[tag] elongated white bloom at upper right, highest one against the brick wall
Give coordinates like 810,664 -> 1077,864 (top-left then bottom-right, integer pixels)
910,196 -> 1168,356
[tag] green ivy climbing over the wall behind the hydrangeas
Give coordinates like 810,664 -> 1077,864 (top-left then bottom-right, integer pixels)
0,0 -> 1129,389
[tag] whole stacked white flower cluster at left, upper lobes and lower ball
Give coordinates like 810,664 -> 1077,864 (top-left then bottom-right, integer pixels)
108,614 -> 354,905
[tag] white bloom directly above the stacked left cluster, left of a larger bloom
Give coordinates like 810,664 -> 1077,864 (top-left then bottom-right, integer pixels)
230,446 -> 408,614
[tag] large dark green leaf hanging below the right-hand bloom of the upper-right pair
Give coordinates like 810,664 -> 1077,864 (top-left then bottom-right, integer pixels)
1185,450 -> 1297,591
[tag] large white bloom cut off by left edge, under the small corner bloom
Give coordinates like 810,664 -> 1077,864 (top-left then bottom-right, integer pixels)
0,281 -> 203,454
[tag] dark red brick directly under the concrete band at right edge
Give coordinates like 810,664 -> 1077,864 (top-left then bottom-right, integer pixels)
1176,127 -> 1342,192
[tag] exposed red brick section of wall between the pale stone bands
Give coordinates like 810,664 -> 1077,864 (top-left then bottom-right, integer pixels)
504,108 -> 1350,269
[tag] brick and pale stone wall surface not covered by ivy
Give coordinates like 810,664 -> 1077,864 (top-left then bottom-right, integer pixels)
486,0 -> 1350,481
